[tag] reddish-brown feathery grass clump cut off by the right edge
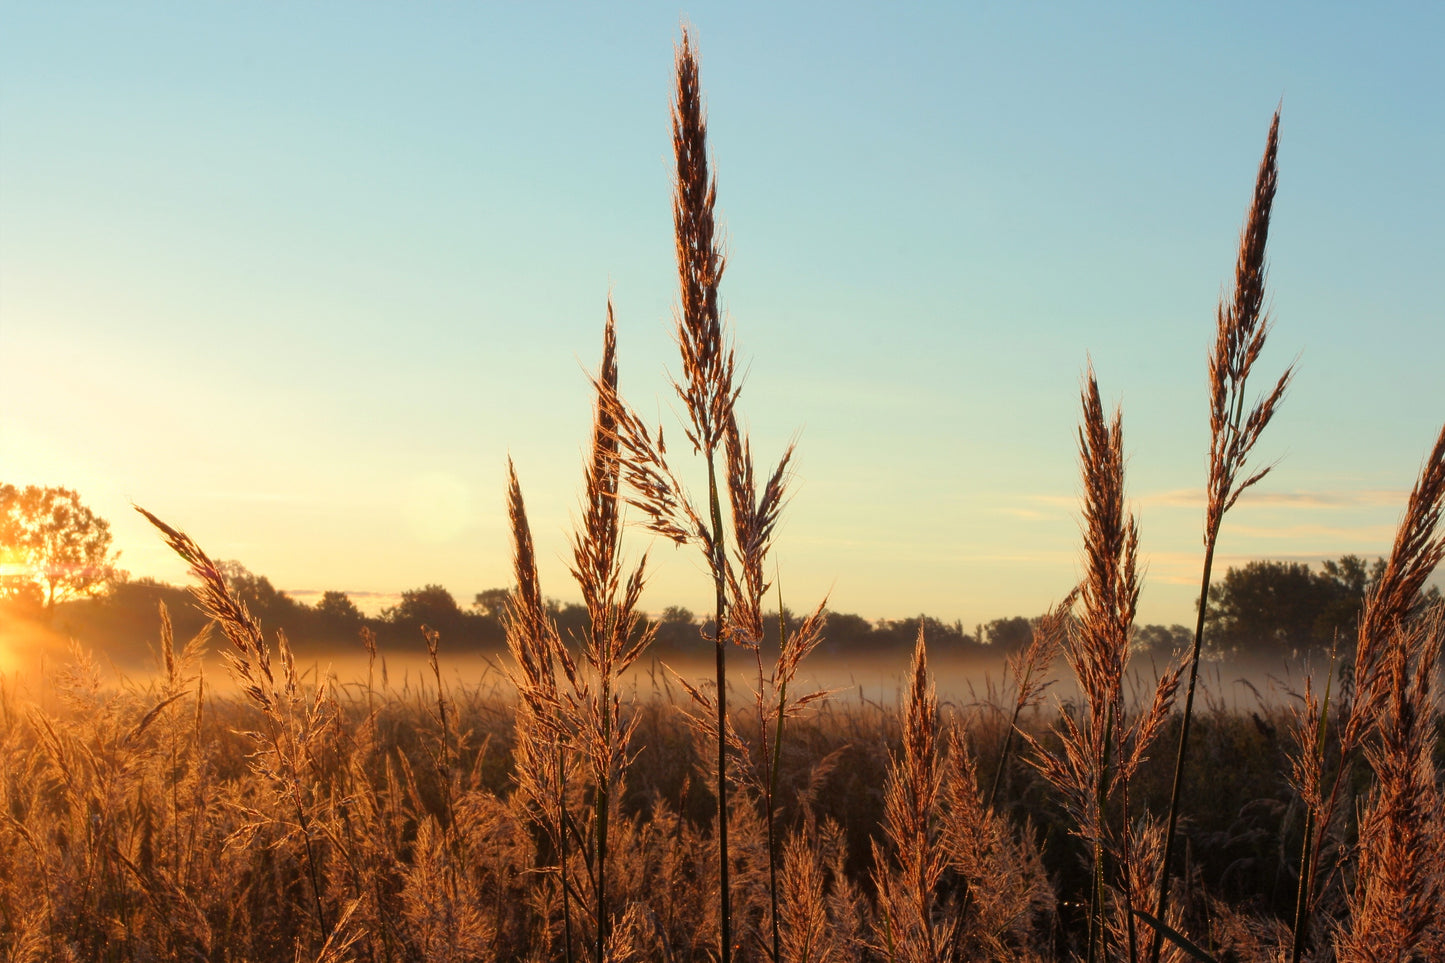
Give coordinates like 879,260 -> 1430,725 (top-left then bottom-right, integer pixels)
1290,427 -> 1445,960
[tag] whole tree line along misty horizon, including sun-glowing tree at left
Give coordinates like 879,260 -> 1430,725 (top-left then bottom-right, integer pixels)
0,484 -> 1441,661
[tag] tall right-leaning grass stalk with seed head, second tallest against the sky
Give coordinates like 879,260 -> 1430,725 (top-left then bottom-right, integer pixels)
1149,110 -> 1293,963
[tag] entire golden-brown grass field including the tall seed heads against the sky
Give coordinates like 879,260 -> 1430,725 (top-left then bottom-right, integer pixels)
0,33 -> 1445,963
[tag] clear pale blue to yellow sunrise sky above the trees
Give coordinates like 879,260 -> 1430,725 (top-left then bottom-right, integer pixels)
0,0 -> 1445,625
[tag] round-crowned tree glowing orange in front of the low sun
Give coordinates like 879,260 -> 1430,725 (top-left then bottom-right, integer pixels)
0,484 -> 124,616
